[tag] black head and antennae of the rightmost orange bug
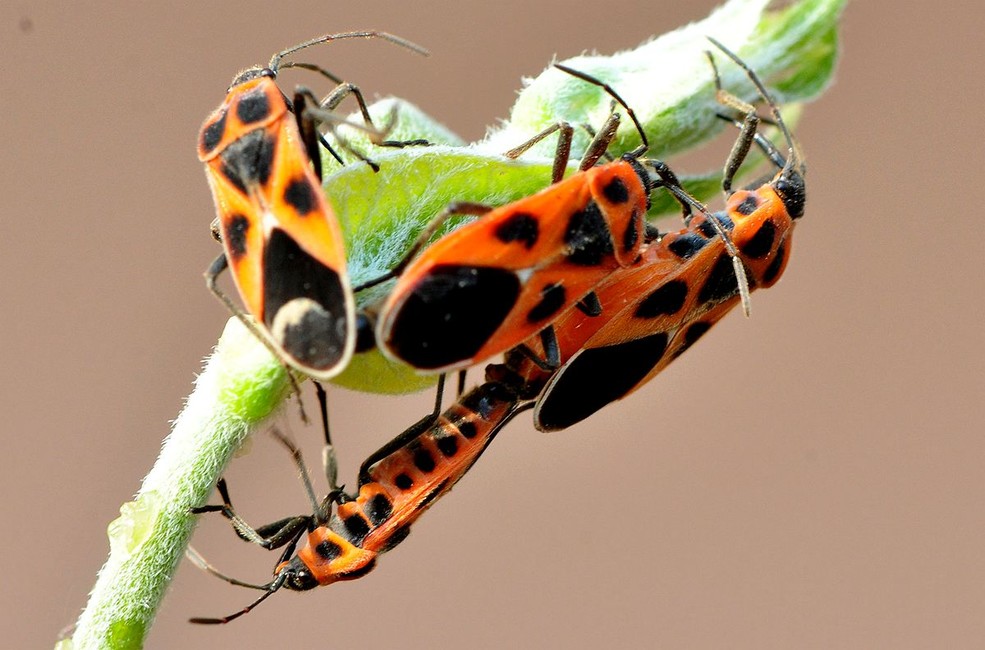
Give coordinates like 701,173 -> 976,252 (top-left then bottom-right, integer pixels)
708,36 -> 807,219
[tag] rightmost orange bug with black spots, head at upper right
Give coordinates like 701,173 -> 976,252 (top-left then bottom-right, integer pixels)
534,39 -> 806,431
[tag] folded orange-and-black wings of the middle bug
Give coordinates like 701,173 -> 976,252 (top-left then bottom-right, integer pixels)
378,165 -> 646,371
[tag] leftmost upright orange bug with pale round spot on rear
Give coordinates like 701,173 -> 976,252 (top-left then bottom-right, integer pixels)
198,31 -> 427,380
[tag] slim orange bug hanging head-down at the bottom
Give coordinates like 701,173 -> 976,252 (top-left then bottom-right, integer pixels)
187,372 -> 532,624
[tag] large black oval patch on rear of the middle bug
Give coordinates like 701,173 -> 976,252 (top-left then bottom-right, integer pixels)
389,264 -> 520,369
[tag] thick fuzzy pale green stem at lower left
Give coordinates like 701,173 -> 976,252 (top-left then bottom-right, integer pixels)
72,318 -> 290,650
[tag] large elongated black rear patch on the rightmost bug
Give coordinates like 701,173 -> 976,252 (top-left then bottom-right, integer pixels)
537,332 -> 668,431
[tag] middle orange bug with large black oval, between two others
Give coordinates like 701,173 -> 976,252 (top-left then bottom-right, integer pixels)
366,64 -> 744,372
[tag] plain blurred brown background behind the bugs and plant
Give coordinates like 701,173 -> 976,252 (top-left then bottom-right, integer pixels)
0,0 -> 985,649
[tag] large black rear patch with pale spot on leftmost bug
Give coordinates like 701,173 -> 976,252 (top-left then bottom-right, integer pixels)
263,228 -> 349,368
